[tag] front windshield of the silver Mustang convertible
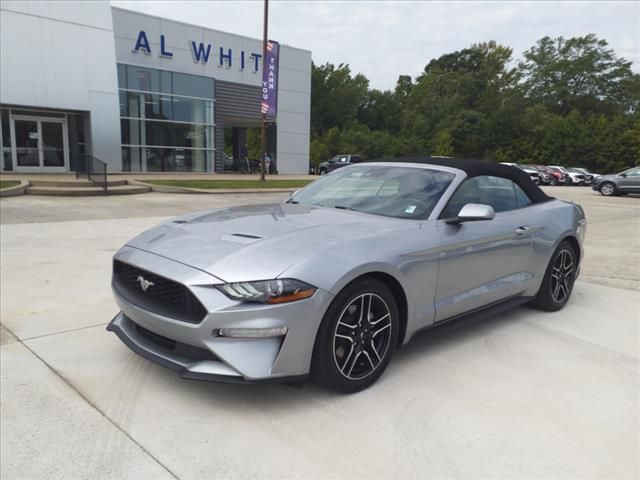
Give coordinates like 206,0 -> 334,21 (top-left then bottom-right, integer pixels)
288,164 -> 455,219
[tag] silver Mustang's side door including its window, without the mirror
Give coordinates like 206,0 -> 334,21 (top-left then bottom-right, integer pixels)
435,176 -> 537,322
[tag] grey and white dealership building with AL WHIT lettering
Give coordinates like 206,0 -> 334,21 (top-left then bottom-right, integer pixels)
0,0 -> 311,174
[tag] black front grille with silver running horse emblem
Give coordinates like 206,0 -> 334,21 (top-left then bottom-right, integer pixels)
113,260 -> 207,323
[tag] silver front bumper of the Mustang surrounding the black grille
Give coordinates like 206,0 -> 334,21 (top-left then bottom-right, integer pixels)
107,247 -> 333,383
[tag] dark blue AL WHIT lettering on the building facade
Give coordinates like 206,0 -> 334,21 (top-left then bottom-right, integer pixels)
132,30 -> 264,73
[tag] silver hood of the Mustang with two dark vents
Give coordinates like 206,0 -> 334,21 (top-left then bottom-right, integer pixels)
127,204 -> 404,282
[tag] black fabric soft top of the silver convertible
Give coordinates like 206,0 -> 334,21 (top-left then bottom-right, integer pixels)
370,157 -> 553,203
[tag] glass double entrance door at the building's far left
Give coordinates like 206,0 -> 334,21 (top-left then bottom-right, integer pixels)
12,116 -> 68,173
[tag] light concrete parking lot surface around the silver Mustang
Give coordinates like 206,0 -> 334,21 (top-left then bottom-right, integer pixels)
0,187 -> 640,480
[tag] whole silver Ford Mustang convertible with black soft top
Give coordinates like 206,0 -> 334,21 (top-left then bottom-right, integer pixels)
108,158 -> 586,392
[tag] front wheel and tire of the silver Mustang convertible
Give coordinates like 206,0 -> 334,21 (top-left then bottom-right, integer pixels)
311,277 -> 400,393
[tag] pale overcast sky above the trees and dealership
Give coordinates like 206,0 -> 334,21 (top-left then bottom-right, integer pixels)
111,0 -> 640,90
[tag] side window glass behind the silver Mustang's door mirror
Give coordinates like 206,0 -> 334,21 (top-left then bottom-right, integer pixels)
440,175 -> 531,218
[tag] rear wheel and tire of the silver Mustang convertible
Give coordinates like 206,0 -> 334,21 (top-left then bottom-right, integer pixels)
530,240 -> 578,312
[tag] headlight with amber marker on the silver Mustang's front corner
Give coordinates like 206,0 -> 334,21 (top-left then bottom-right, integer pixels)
214,278 -> 317,305
